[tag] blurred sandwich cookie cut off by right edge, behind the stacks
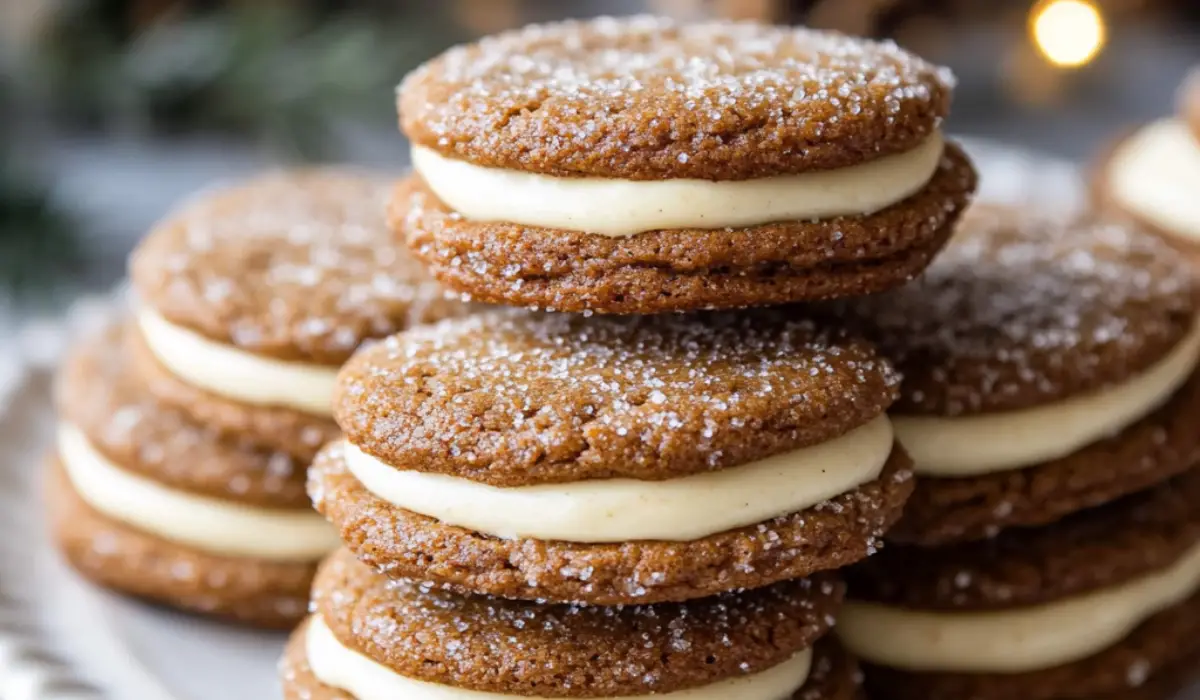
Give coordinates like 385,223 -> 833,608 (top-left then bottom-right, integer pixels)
1092,70 -> 1200,261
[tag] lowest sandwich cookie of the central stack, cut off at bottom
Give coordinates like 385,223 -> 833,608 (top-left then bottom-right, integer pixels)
281,550 -> 858,700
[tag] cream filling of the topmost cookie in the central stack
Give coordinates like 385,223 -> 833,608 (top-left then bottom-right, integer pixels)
413,133 -> 944,237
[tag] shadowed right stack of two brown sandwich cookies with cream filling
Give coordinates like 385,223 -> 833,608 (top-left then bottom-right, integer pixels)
838,205 -> 1200,700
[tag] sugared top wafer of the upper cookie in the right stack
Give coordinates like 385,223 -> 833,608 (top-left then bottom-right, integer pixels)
845,208 -> 1198,417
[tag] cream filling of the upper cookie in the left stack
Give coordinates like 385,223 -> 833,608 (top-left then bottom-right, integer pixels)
138,307 -> 337,415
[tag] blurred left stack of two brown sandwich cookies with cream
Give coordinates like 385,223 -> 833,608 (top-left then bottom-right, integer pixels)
49,170 -> 463,627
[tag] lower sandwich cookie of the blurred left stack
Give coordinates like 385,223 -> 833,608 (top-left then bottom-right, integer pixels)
49,323 -> 337,627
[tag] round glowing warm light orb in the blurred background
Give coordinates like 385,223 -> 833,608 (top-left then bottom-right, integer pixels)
1030,0 -> 1108,68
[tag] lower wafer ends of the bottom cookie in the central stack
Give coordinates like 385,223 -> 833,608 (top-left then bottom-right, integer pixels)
280,621 -> 864,700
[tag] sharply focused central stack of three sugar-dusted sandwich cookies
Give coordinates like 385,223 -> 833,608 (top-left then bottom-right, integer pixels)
282,17 -> 974,700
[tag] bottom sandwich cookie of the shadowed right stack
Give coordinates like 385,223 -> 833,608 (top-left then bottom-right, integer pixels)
838,469 -> 1200,700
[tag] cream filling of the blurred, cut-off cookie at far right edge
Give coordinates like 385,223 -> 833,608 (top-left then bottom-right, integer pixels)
1106,119 -> 1200,243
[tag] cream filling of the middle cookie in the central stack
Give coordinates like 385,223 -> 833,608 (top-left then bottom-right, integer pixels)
346,415 -> 894,543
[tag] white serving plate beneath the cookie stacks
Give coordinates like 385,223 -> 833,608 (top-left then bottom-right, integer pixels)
0,143 -> 1200,700
